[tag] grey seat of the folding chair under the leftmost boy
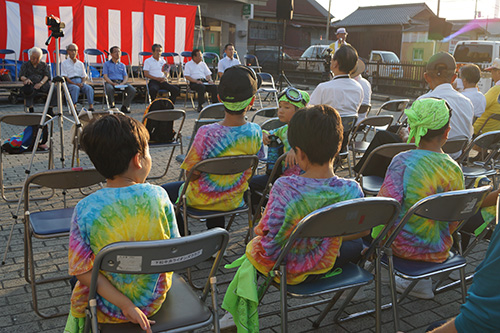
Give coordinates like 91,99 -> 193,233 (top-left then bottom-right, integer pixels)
99,274 -> 212,333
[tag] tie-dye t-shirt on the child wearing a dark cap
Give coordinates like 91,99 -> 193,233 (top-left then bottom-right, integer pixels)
181,123 -> 263,211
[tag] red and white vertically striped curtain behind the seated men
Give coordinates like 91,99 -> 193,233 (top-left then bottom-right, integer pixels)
0,0 -> 196,64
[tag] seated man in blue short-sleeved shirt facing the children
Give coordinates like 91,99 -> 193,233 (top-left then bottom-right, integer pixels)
103,46 -> 136,113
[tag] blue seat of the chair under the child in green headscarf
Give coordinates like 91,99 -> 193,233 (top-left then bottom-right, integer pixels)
382,252 -> 467,278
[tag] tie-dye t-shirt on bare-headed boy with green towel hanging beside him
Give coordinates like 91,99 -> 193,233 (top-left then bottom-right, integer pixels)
246,176 -> 363,284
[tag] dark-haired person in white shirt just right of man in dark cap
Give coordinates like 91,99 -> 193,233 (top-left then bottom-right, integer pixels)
460,64 -> 486,118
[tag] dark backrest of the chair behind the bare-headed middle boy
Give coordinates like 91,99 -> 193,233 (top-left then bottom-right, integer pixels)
273,197 -> 401,270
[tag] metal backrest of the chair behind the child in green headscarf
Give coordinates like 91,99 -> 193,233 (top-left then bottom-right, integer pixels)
385,186 -> 491,247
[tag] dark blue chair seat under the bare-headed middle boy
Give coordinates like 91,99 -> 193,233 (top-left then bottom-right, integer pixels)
286,263 -> 373,297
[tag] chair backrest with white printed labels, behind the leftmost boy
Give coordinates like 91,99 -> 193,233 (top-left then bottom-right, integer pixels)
89,228 -> 229,300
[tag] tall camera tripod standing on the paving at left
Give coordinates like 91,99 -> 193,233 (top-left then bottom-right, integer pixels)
2,16 -> 82,266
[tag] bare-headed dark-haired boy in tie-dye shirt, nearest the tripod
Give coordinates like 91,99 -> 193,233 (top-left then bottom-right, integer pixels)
65,115 -> 179,332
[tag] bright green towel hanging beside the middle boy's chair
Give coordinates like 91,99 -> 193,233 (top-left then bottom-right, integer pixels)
222,255 -> 259,333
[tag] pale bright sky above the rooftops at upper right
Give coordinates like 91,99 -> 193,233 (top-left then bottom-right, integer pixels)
316,0 -> 500,21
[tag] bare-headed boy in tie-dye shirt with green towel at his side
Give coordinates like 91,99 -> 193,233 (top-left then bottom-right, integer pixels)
246,105 -> 363,284
